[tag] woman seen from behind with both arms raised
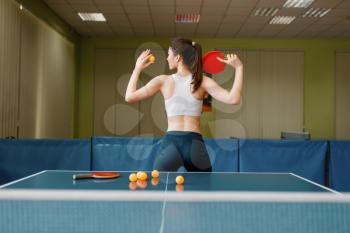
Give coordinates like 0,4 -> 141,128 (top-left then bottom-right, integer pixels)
125,38 -> 243,172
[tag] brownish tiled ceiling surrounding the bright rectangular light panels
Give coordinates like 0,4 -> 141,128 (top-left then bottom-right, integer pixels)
44,0 -> 350,39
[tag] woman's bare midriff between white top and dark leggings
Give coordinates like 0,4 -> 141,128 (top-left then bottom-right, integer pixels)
167,116 -> 201,133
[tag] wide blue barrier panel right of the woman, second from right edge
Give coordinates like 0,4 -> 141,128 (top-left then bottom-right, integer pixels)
239,139 -> 327,185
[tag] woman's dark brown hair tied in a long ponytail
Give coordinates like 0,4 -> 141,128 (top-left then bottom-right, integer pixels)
170,37 -> 203,93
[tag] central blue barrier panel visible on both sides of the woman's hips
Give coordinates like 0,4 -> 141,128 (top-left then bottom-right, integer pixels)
92,137 -> 238,172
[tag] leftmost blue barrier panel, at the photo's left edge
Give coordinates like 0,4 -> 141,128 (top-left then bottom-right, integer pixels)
0,139 -> 91,184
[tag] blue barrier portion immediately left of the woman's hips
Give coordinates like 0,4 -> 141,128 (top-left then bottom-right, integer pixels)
92,137 -> 159,171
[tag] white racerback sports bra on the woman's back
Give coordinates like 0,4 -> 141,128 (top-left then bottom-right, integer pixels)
165,74 -> 203,117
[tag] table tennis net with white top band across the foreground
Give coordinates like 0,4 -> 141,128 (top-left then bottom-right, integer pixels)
0,191 -> 350,233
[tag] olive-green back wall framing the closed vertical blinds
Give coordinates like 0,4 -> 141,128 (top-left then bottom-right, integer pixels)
76,37 -> 350,139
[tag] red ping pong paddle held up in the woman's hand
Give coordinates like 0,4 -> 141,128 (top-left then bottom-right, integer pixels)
202,51 -> 225,74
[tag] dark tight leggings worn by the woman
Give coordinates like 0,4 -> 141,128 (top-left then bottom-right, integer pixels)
154,131 -> 212,172
